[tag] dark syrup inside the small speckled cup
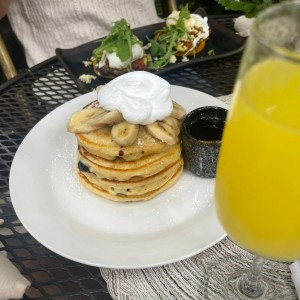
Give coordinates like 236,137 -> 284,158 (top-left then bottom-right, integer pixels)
189,120 -> 224,141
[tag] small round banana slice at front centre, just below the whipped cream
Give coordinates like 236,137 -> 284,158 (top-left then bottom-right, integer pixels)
111,121 -> 139,146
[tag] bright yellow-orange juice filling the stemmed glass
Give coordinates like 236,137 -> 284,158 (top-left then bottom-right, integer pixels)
216,58 -> 300,260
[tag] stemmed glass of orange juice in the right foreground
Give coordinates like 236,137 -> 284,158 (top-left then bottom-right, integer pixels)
215,1 -> 300,299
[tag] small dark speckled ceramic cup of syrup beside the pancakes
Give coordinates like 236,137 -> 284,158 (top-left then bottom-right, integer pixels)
182,106 -> 227,178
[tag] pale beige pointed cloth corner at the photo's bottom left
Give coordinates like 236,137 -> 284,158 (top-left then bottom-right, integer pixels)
0,219 -> 30,300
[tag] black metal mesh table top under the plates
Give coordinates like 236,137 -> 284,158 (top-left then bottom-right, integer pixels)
0,15 -> 240,300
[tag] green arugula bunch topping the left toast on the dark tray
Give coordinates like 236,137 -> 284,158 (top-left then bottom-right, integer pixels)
92,19 -> 142,61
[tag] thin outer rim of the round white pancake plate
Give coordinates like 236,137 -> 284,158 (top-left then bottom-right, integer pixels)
9,85 -> 228,269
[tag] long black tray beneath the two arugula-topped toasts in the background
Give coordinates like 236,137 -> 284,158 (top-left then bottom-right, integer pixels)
56,10 -> 246,93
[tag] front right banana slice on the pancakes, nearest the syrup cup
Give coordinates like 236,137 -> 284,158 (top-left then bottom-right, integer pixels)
145,117 -> 179,145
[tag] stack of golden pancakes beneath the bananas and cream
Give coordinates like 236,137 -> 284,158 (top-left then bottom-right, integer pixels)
68,102 -> 184,201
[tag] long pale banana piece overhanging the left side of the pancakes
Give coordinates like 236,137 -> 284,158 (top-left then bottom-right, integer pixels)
67,108 -> 124,133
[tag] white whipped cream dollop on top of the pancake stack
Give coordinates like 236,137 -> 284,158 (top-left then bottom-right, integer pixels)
98,71 -> 173,125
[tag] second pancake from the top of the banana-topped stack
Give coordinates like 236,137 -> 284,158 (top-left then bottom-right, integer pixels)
78,144 -> 181,181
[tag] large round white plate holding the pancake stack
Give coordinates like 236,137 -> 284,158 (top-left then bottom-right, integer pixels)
10,86 -> 226,269
